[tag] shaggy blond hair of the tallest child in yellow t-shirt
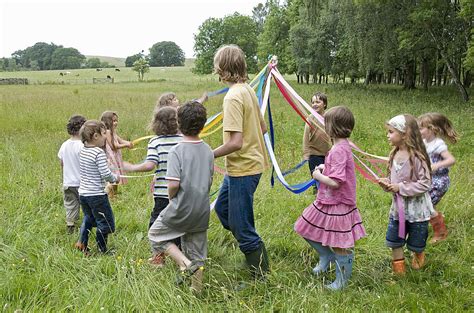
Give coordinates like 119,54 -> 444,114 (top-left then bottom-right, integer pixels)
214,45 -> 248,83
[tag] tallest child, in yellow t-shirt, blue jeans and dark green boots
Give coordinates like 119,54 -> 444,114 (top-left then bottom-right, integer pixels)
214,45 -> 270,278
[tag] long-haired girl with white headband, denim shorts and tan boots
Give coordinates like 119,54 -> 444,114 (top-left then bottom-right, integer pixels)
379,114 -> 433,275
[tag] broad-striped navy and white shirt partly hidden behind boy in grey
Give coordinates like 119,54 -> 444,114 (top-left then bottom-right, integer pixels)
146,135 -> 183,199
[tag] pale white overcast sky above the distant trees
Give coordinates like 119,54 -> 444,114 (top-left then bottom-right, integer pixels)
0,0 -> 264,58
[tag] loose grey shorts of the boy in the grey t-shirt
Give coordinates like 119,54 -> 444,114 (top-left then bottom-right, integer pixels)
148,216 -> 207,265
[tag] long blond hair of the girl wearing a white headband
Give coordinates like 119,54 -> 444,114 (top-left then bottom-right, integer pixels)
387,114 -> 431,178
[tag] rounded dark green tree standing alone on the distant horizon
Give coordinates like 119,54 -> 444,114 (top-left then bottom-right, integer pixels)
148,41 -> 185,66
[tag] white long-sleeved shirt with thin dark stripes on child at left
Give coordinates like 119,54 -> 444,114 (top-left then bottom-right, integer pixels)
79,147 -> 118,196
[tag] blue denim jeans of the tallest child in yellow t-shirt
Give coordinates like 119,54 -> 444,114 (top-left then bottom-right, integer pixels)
215,174 -> 262,254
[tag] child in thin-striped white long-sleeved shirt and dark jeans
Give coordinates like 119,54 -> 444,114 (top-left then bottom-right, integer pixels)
75,120 -> 119,255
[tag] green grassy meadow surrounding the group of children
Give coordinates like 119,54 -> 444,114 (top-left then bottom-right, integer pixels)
0,67 -> 474,312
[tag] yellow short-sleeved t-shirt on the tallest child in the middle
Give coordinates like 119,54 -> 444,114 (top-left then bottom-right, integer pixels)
223,83 -> 268,176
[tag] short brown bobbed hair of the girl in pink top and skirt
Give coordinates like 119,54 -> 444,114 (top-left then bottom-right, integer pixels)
324,106 -> 355,138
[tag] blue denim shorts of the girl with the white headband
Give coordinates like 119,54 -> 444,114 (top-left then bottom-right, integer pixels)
385,218 -> 429,253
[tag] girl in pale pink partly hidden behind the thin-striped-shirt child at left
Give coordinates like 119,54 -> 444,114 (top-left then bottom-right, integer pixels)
100,111 -> 133,197
